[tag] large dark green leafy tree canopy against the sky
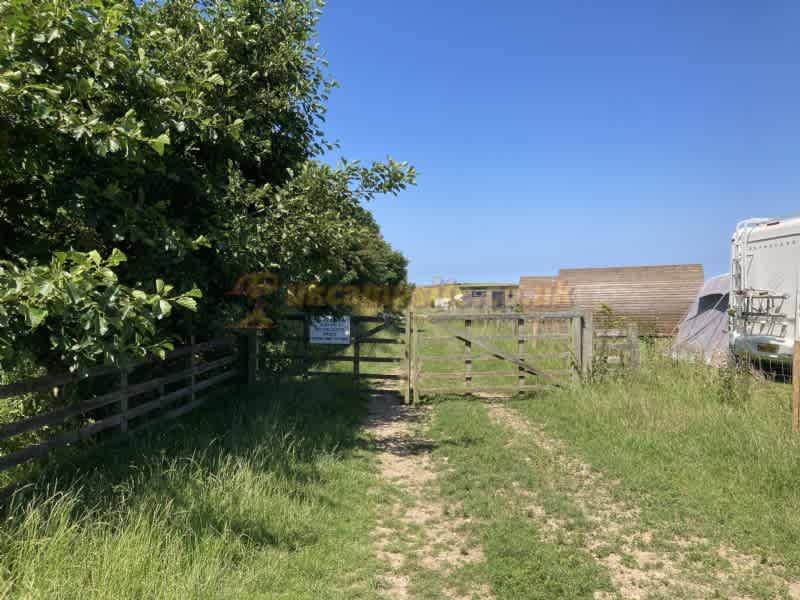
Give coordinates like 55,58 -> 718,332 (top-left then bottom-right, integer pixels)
0,0 -> 415,370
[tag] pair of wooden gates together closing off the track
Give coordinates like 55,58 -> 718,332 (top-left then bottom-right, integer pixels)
268,311 -> 594,403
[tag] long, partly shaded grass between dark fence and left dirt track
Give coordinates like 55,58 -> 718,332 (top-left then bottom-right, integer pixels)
0,381 -> 379,599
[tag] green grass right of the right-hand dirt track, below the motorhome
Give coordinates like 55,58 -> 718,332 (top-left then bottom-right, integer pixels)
512,353 -> 800,577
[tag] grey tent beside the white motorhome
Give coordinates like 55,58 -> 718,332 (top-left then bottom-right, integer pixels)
672,273 -> 731,366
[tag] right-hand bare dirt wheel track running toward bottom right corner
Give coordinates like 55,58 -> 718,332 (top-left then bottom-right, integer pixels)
487,403 -> 800,599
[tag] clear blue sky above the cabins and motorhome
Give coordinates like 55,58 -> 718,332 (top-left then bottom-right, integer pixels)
319,0 -> 800,283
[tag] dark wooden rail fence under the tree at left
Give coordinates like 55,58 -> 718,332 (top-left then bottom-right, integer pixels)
0,336 -> 241,471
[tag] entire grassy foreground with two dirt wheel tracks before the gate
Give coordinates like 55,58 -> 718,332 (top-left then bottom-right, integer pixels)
0,336 -> 800,600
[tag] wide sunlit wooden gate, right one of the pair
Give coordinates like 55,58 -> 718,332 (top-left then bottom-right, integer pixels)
405,311 -> 593,402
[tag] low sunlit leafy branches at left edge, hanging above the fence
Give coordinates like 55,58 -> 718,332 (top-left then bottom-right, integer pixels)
0,250 -> 201,371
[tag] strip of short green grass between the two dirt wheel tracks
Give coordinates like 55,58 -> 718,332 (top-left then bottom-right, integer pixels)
429,399 -> 611,600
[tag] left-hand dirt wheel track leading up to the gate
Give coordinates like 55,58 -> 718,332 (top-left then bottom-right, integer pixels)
366,391 -> 492,598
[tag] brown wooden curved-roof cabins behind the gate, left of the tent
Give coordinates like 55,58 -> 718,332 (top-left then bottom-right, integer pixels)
519,264 -> 704,335
